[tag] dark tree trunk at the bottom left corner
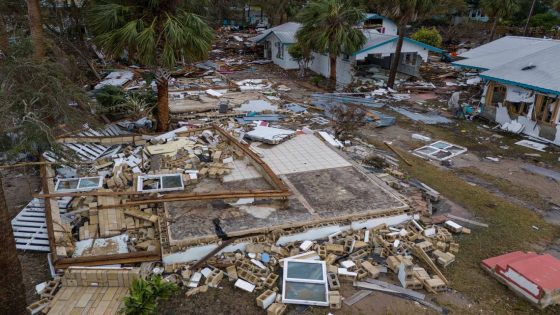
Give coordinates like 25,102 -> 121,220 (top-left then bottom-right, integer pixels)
0,174 -> 27,315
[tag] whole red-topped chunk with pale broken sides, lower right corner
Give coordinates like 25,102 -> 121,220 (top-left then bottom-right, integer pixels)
481,251 -> 560,308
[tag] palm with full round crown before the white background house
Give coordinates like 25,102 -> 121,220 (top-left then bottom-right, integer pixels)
296,0 -> 366,90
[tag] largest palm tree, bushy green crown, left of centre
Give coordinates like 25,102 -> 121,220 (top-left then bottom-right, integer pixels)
88,0 -> 214,131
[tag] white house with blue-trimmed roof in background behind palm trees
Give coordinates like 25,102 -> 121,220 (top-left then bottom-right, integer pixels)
252,20 -> 443,85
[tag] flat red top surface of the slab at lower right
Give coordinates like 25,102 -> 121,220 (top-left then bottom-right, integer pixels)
509,254 -> 560,290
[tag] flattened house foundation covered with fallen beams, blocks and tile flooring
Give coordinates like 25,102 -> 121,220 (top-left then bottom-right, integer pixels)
12,124 -> 413,270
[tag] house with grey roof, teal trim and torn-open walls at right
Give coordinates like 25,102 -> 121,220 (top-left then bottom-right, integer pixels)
453,36 -> 560,145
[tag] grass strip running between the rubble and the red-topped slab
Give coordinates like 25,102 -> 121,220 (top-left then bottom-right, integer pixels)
358,137 -> 560,314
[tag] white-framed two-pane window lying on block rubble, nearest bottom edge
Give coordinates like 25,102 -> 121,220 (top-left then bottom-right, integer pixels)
282,259 -> 329,306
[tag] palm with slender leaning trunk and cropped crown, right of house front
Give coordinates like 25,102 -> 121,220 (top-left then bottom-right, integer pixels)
377,0 -> 437,88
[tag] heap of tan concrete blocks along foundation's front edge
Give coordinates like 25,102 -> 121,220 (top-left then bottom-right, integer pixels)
158,220 -> 470,314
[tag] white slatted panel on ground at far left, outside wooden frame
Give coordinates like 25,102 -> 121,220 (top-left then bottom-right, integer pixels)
12,197 -> 72,252
